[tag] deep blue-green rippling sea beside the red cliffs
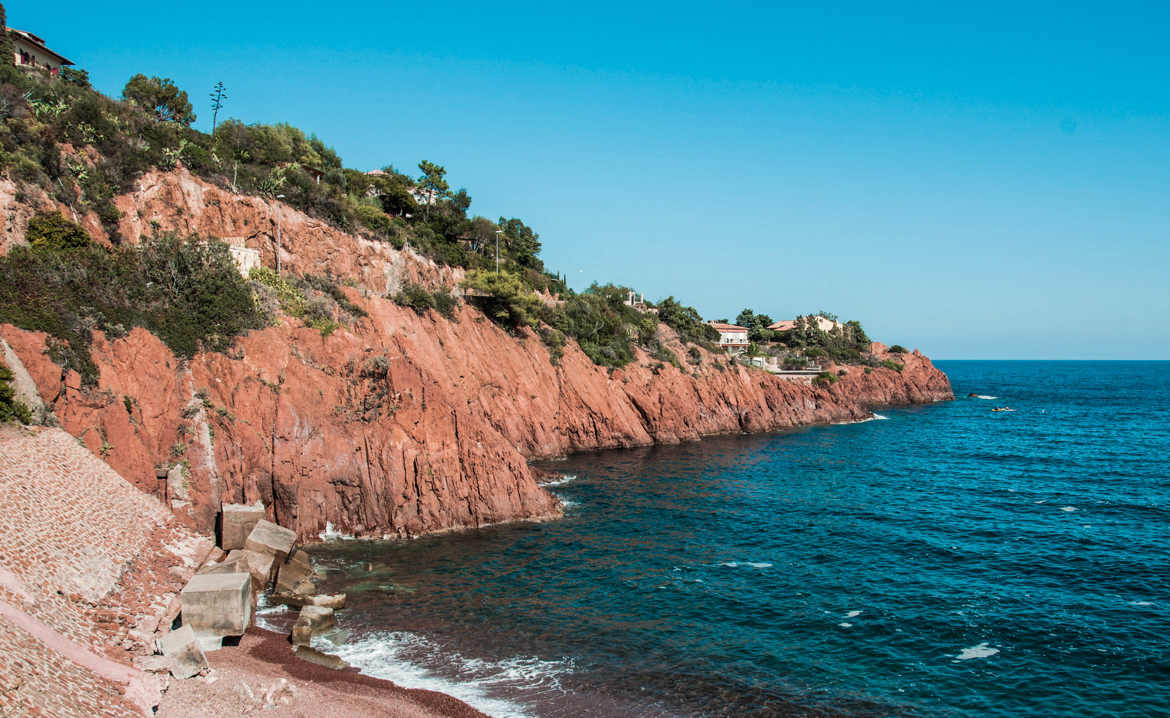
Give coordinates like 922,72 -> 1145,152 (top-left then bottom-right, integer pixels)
304,361 -> 1170,718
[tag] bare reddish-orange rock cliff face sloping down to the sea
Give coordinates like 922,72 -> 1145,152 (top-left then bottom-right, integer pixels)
0,171 -> 952,539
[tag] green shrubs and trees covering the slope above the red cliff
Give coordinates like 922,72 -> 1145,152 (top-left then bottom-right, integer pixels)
0,39 -> 884,382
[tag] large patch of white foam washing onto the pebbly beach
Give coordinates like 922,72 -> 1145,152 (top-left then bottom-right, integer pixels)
329,631 -> 572,718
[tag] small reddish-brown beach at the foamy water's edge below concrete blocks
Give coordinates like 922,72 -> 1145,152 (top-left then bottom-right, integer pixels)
157,628 -> 488,718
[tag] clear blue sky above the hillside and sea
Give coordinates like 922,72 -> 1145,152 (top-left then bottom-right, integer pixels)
5,0 -> 1170,359
